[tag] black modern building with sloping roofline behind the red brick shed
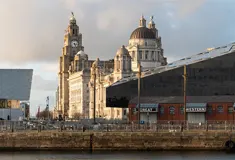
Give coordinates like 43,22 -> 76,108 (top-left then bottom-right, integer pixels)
106,43 -> 235,107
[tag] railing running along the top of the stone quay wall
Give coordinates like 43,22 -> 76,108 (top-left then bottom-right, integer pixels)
0,121 -> 235,132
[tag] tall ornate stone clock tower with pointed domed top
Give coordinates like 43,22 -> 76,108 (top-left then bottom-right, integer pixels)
57,13 -> 83,117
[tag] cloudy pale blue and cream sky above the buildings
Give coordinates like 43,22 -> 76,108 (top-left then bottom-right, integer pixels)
0,0 -> 235,116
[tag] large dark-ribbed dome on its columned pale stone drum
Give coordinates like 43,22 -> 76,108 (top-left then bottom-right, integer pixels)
127,16 -> 167,72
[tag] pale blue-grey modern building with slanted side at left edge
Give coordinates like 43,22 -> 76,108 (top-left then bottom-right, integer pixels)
0,69 -> 33,120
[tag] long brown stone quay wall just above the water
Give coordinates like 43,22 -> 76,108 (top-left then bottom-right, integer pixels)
0,132 -> 235,151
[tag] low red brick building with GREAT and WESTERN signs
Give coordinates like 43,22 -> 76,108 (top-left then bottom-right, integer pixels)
128,96 -> 235,123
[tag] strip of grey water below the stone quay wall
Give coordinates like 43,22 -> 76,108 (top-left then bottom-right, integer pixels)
0,151 -> 235,160
